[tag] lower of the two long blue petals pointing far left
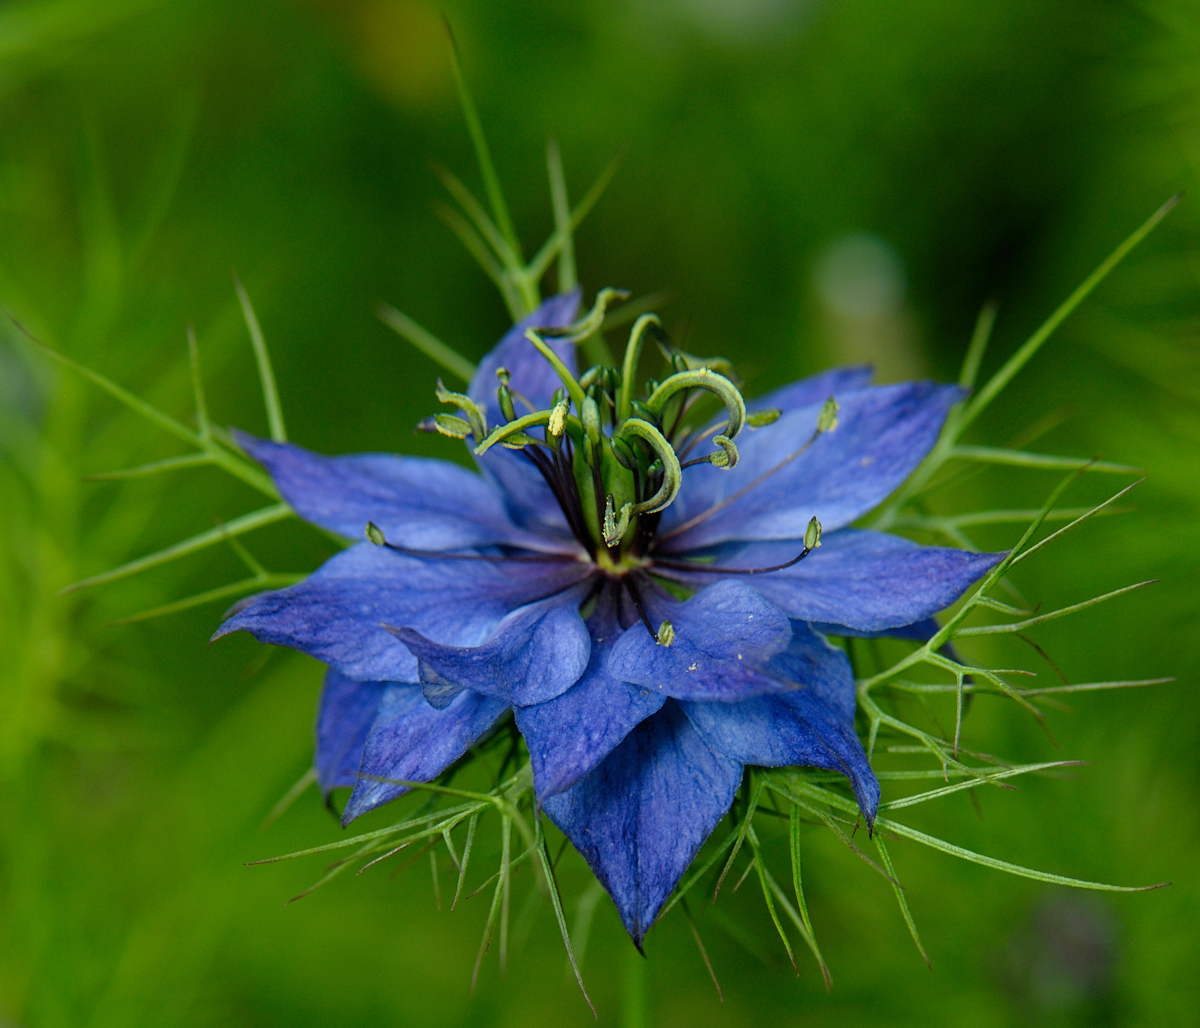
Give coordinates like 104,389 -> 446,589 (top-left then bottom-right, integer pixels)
212,542 -> 588,681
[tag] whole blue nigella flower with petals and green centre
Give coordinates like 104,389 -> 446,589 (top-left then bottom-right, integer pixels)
217,294 -> 998,945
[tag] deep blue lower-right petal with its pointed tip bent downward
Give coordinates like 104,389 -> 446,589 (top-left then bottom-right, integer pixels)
682,630 -> 880,824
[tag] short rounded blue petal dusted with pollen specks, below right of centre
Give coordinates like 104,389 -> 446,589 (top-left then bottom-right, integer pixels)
608,579 -> 792,701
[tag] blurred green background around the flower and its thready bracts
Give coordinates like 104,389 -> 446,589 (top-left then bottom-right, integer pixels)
0,0 -> 1200,1028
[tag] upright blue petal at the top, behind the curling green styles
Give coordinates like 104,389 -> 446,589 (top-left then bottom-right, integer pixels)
468,290 -> 580,540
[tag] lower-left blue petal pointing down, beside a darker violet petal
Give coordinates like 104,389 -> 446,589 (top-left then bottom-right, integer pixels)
342,684 -> 508,825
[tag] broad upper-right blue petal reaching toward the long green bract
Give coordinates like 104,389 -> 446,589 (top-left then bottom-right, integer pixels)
661,381 -> 964,553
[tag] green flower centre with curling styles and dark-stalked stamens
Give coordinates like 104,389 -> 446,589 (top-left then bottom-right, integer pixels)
421,289 -> 780,561
